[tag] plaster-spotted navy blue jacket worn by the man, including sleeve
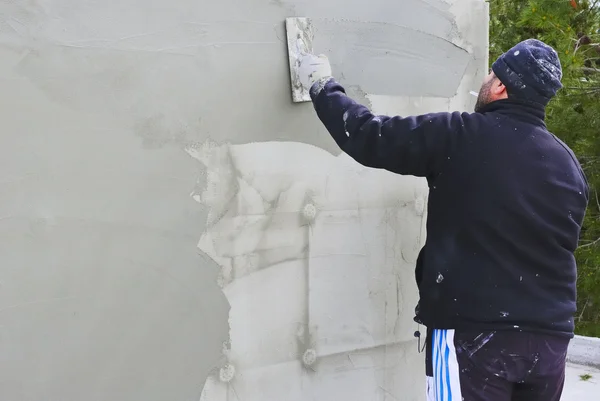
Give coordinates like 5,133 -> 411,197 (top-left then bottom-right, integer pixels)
311,80 -> 589,337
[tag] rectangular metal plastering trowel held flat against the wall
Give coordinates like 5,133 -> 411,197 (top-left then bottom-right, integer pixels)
285,17 -> 314,103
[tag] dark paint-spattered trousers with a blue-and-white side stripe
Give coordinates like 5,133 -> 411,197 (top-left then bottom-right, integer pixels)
426,330 -> 569,401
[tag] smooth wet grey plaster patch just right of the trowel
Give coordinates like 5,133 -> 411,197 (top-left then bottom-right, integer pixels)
313,20 -> 471,97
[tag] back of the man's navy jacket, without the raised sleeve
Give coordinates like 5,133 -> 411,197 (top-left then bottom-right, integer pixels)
417,100 -> 588,336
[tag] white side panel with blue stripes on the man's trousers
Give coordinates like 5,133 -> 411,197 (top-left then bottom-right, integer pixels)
427,330 -> 462,401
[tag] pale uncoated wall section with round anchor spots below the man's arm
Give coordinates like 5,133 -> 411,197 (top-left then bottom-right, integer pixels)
188,142 -> 427,401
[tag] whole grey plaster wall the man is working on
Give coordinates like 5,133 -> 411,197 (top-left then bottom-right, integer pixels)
0,0 -> 488,401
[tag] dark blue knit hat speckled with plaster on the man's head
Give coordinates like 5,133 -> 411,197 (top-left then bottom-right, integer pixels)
492,39 -> 562,105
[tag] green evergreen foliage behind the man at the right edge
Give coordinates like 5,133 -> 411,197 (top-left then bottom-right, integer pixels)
488,0 -> 600,337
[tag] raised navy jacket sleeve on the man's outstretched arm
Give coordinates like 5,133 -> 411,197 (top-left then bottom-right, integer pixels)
311,79 -> 469,177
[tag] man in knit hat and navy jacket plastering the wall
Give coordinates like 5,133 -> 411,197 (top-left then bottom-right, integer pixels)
300,40 -> 589,401
